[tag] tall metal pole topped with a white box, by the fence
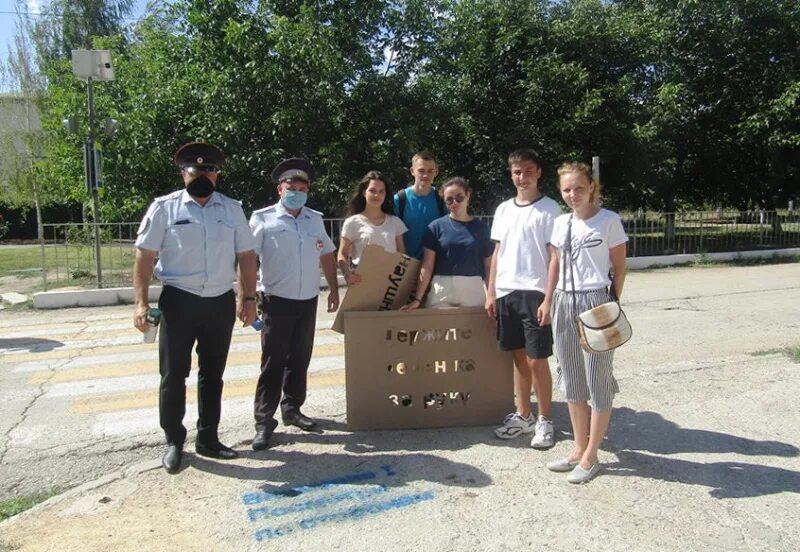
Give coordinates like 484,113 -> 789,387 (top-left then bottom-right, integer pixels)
70,50 -> 116,288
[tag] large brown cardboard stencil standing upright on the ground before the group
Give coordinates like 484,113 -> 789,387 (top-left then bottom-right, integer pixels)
344,307 -> 514,430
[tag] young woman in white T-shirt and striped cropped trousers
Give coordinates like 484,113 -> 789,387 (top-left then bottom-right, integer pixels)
547,163 -> 628,483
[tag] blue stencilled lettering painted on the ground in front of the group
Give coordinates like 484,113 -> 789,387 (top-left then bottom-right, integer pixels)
242,466 -> 434,541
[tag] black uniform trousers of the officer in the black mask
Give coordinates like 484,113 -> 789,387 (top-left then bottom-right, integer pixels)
158,286 -> 236,445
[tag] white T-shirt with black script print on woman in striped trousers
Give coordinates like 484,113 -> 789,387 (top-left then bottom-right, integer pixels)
550,209 -> 628,291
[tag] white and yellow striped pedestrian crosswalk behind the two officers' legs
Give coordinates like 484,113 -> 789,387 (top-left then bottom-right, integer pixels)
0,311 -> 345,442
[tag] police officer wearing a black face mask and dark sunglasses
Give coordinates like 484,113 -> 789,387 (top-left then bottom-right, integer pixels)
133,142 -> 256,473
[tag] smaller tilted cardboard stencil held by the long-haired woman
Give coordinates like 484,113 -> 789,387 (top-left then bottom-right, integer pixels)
332,245 -> 419,333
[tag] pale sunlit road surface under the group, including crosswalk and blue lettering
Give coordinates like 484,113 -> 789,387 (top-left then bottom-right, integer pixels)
0,264 -> 800,551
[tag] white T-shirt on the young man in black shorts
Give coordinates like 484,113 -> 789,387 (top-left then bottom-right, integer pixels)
491,196 -> 561,299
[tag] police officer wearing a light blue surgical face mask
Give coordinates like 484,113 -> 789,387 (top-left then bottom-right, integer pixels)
250,158 -> 339,450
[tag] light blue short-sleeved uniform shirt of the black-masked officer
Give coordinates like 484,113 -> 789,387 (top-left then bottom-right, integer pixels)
136,189 -> 255,297
